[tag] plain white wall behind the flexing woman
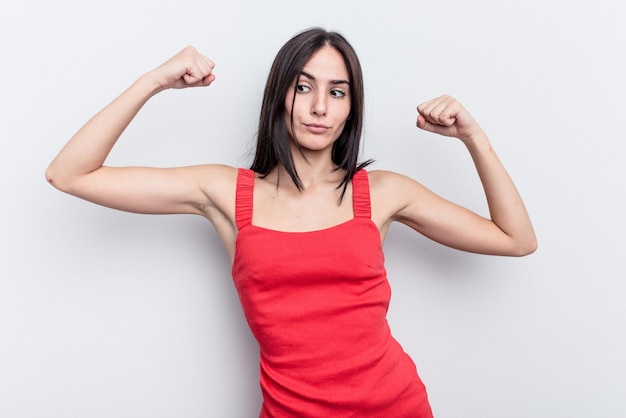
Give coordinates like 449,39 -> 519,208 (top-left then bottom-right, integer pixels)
0,0 -> 626,418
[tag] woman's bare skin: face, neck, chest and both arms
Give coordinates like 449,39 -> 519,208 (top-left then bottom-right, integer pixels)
46,47 -> 537,261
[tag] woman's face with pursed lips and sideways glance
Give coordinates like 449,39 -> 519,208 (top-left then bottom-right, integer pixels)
285,46 -> 351,151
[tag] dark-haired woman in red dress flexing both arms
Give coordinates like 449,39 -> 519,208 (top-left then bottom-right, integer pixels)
46,28 -> 537,417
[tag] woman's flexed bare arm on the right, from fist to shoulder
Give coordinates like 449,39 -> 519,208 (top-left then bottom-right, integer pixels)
378,95 -> 537,256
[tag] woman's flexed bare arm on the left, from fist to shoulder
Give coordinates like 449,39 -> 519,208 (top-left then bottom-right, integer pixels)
46,47 -> 236,222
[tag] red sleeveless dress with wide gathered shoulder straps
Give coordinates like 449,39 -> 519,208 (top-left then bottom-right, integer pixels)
232,169 -> 432,418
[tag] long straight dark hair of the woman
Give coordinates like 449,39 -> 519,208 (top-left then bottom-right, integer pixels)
250,28 -> 372,200
